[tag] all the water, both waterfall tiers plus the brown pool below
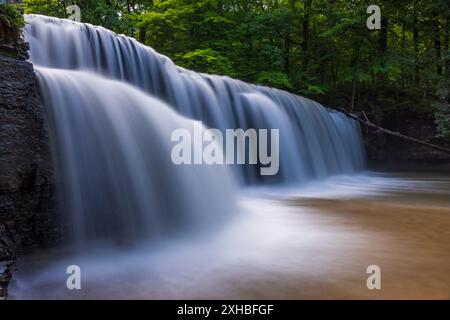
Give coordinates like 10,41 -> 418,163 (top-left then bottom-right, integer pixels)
8,16 -> 450,302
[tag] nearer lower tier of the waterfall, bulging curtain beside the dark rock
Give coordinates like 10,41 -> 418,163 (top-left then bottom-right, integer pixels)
36,67 -> 234,245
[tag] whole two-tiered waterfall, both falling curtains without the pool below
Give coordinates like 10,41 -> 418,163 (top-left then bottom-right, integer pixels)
25,16 -> 364,245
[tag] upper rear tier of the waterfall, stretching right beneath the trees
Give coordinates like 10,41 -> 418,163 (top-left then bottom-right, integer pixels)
26,15 -> 365,184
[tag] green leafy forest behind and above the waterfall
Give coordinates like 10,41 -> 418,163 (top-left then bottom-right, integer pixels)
20,0 -> 450,139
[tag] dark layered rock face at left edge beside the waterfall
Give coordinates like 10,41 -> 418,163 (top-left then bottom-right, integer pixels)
0,56 -> 58,262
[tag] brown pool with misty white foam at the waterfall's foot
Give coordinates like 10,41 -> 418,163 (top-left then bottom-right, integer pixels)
10,173 -> 450,299
